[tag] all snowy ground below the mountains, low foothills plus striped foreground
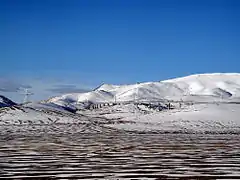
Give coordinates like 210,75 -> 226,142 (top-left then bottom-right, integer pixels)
0,103 -> 240,180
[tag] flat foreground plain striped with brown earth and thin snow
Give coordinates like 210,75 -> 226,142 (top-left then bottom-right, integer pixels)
0,132 -> 240,180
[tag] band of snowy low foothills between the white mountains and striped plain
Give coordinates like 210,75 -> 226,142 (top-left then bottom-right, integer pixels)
0,103 -> 240,133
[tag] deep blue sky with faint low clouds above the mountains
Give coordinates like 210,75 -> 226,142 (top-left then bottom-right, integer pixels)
0,0 -> 240,99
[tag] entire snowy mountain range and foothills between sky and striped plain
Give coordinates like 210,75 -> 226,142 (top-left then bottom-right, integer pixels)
0,74 -> 240,133
